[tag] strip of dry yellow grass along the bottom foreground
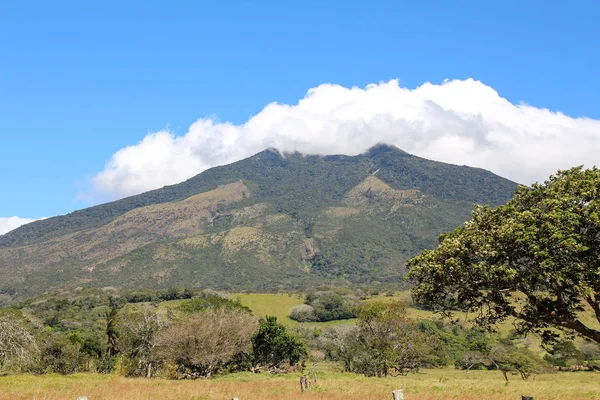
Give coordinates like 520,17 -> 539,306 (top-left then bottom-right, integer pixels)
0,365 -> 600,400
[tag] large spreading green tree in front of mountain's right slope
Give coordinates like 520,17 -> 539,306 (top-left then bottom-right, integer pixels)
407,167 -> 600,343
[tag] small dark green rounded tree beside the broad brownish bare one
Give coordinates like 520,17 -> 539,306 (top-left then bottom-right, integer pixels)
252,316 -> 308,368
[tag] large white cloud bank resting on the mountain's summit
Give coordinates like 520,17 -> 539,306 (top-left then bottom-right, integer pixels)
91,79 -> 600,201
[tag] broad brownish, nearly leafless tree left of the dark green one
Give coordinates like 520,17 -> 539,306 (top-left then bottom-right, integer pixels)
153,307 -> 256,378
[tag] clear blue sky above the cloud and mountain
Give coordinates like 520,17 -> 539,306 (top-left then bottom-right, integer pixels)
0,0 -> 600,225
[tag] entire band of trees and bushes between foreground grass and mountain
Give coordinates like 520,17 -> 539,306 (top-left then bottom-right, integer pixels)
0,290 -> 600,379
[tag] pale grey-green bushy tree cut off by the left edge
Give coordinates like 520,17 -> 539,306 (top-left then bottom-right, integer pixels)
0,309 -> 39,370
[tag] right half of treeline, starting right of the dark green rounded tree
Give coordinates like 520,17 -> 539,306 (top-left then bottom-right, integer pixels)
292,301 -> 600,380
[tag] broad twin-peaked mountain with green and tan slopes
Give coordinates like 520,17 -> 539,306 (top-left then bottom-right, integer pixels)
0,145 -> 517,298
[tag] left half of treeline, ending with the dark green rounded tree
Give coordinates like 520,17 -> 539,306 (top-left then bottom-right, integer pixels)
0,292 -> 308,379
